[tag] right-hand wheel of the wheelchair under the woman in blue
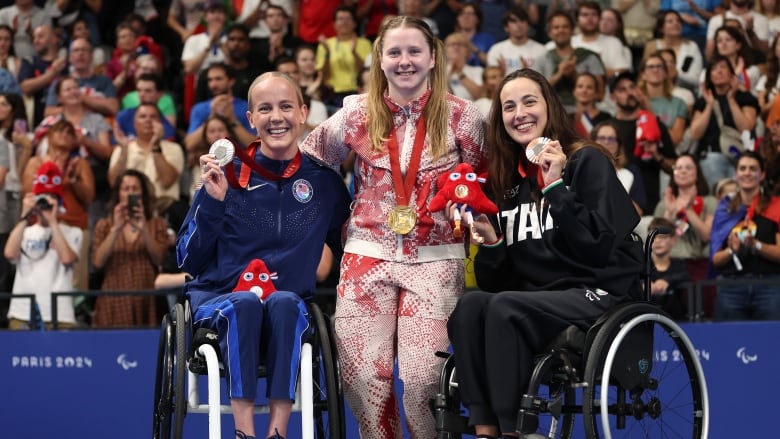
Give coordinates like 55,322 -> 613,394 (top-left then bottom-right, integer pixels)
310,303 -> 346,439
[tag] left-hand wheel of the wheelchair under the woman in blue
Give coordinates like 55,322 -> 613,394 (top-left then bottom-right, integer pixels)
152,304 -> 187,439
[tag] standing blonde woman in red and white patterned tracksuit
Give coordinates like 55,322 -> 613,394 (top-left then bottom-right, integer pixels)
302,17 -> 485,439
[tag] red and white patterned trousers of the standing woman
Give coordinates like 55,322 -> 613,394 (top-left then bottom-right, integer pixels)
335,253 -> 464,439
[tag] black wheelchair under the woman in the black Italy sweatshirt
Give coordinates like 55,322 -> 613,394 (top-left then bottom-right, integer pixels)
432,229 -> 710,439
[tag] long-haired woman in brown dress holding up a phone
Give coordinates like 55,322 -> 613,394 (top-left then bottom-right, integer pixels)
92,169 -> 168,327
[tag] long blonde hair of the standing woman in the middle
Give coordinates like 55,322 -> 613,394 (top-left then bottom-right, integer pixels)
366,16 -> 449,159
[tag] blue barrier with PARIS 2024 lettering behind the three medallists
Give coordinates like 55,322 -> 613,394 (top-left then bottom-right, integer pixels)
0,322 -> 780,439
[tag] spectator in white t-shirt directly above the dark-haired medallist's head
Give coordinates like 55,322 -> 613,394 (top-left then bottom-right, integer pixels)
487,7 -> 546,74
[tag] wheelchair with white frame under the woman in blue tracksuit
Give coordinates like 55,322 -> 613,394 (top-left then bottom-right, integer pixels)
152,301 -> 346,439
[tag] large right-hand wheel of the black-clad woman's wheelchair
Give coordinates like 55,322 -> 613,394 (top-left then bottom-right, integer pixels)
583,303 -> 709,439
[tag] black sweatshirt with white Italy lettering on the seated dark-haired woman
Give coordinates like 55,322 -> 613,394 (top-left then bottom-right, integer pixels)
475,147 -> 643,297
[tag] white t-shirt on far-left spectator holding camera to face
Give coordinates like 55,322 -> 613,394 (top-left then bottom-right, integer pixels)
8,223 -> 83,323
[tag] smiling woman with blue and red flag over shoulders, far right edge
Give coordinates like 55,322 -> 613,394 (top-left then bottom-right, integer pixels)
710,151 -> 780,320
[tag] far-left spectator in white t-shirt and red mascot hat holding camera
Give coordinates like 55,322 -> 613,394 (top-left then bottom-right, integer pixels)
4,161 -> 82,330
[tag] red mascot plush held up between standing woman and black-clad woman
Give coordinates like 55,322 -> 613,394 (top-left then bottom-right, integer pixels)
428,163 -> 498,244
